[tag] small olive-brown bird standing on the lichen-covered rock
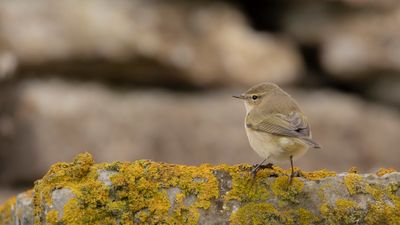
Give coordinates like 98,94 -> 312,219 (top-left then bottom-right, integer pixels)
233,82 -> 321,180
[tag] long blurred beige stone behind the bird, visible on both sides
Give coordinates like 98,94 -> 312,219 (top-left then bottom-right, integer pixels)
0,80 -> 400,185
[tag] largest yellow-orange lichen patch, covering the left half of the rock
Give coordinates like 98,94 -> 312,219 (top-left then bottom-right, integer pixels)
34,154 -> 219,224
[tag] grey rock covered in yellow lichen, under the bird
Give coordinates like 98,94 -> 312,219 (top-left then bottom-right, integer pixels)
0,153 -> 400,225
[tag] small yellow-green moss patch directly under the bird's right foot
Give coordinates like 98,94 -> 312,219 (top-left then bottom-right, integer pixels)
271,176 -> 304,203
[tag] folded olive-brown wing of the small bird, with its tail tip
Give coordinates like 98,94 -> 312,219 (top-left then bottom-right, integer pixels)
246,112 -> 320,148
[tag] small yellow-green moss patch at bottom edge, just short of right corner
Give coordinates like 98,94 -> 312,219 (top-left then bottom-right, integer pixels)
320,199 -> 363,225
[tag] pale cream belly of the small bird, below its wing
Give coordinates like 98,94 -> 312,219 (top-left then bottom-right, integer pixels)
246,128 -> 308,161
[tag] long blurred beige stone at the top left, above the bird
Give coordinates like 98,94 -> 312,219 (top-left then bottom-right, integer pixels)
0,0 -> 302,86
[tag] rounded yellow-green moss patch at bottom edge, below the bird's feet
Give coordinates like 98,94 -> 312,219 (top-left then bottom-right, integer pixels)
230,203 -> 292,225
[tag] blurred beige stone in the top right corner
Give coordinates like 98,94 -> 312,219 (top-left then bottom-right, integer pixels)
284,1 -> 400,80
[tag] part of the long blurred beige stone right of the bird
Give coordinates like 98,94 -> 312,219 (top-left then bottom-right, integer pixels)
293,91 -> 400,171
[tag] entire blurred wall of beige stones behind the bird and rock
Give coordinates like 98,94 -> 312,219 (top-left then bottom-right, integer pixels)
0,0 -> 400,202
